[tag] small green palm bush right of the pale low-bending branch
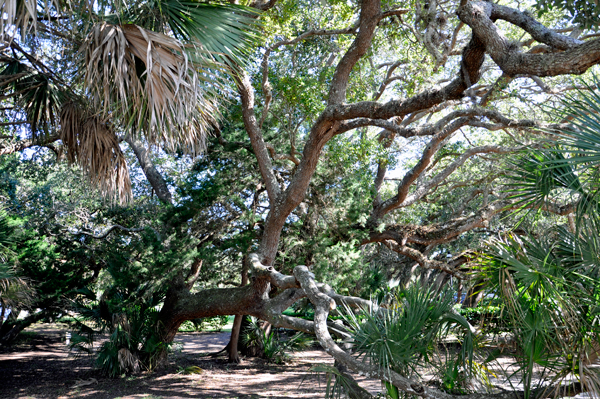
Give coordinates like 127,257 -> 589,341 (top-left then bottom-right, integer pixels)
345,283 -> 475,397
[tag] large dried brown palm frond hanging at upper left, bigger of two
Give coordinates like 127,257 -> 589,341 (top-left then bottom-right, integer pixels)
82,22 -> 218,153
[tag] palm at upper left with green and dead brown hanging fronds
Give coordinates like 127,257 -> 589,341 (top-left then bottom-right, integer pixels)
0,0 -> 257,199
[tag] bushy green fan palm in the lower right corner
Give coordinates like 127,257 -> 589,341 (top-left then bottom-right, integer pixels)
481,233 -> 600,397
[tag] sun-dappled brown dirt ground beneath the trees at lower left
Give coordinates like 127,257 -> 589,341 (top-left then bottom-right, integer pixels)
0,327 -> 381,399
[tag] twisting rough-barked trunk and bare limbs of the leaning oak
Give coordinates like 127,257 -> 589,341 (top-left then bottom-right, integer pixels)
154,0 -> 600,399
